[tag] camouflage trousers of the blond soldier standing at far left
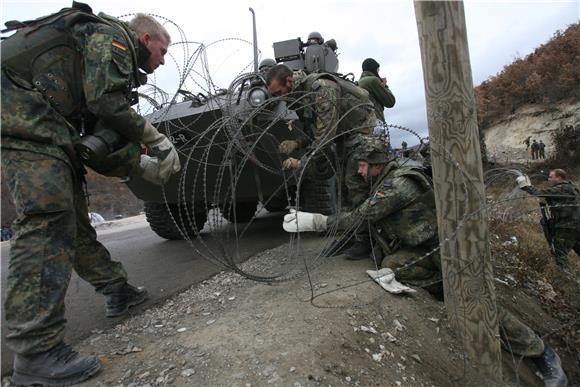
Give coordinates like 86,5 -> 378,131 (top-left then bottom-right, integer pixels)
2,149 -> 127,355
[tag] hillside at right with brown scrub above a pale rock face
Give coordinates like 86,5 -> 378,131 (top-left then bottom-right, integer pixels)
475,23 -> 580,163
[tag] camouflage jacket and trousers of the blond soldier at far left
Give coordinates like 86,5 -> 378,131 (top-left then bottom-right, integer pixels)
1,9 -> 146,355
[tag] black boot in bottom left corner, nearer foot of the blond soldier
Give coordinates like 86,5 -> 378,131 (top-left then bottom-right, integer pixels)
12,343 -> 101,386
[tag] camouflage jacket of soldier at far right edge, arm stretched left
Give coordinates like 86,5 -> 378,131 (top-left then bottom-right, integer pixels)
523,181 -> 580,233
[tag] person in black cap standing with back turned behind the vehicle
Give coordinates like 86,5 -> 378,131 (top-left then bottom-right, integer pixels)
358,58 -> 395,129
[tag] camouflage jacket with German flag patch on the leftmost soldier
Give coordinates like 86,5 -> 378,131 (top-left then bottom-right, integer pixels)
2,8 -> 145,165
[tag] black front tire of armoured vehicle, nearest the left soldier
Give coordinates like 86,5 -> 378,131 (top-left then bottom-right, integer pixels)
145,202 -> 207,240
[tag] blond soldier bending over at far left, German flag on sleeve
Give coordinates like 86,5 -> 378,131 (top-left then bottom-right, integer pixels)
1,2 -> 180,385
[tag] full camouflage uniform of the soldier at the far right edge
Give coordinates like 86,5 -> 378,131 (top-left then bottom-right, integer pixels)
523,181 -> 580,268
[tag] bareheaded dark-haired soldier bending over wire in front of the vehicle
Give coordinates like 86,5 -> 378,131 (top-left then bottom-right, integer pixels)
266,64 -> 386,257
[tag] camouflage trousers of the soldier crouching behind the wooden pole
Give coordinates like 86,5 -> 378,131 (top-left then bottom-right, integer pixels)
381,243 -> 544,357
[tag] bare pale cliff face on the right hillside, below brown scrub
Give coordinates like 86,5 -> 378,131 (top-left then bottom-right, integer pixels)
481,102 -> 580,163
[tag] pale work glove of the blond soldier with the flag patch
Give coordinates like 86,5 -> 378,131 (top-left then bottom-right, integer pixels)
141,122 -> 181,183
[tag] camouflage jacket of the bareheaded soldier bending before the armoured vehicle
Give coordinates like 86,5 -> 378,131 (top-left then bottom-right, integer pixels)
289,70 -> 376,144
